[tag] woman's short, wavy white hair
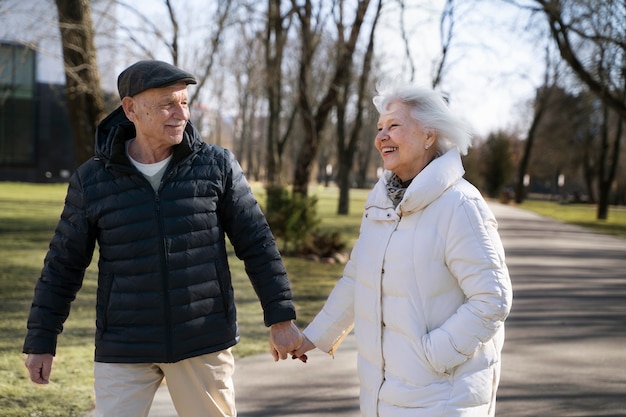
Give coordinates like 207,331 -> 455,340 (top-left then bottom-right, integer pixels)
373,84 -> 472,155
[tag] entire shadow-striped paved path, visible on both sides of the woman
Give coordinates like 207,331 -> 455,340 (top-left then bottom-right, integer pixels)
134,203 -> 626,417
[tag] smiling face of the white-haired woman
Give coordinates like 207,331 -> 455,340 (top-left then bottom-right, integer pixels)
375,101 -> 436,181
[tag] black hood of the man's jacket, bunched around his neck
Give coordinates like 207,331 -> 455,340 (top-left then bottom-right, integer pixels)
95,106 -> 204,160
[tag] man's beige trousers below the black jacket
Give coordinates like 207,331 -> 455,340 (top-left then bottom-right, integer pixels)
94,349 -> 237,417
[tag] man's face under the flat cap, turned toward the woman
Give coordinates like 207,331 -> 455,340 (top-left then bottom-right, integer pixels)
122,82 -> 189,149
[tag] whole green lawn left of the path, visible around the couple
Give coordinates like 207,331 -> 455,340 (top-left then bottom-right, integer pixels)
0,183 -> 367,417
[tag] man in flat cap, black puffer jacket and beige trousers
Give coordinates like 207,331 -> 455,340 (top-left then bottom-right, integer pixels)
24,61 -> 302,417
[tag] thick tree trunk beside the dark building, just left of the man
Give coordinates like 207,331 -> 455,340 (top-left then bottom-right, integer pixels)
56,0 -> 105,163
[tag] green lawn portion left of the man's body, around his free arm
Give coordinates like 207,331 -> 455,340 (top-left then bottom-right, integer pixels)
0,183 -> 95,417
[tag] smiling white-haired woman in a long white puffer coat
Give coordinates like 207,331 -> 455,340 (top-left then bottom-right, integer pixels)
293,86 -> 512,417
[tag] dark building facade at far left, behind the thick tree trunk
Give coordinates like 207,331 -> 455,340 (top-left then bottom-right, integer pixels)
0,42 -> 76,182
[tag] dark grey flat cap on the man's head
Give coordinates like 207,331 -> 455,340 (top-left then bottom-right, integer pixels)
117,60 -> 197,98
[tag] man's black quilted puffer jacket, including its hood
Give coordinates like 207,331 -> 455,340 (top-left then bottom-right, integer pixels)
24,108 -> 295,363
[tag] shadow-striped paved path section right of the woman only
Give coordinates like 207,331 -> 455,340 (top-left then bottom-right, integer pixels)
493,201 -> 626,417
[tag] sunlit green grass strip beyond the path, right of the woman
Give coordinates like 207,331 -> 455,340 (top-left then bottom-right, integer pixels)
519,200 -> 626,237
